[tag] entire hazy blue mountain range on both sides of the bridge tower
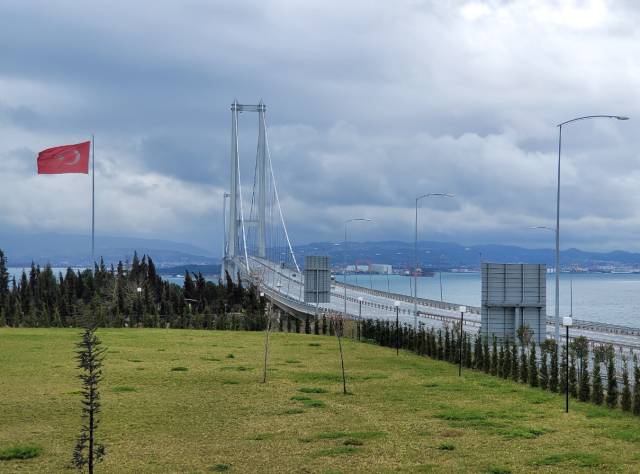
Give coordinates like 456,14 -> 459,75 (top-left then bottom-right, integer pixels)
5,233 -> 640,271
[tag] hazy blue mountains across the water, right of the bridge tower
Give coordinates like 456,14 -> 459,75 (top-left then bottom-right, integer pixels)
294,241 -> 640,270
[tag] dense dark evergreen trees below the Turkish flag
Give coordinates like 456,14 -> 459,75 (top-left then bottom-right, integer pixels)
0,250 -> 265,330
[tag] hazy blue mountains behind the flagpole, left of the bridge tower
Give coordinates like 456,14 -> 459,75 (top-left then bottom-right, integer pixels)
0,233 -> 220,267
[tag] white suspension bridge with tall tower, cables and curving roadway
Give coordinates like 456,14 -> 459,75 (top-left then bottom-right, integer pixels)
222,101 -> 640,362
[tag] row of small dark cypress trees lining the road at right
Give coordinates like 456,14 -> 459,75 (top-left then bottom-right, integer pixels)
361,319 -> 640,415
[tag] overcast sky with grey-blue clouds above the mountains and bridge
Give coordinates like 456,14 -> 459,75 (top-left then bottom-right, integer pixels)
0,0 -> 640,254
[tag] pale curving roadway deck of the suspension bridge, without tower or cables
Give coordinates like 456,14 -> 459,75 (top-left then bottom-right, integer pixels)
237,257 -> 640,353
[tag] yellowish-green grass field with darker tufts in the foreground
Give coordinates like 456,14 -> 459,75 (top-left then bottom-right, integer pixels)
0,329 -> 640,473
